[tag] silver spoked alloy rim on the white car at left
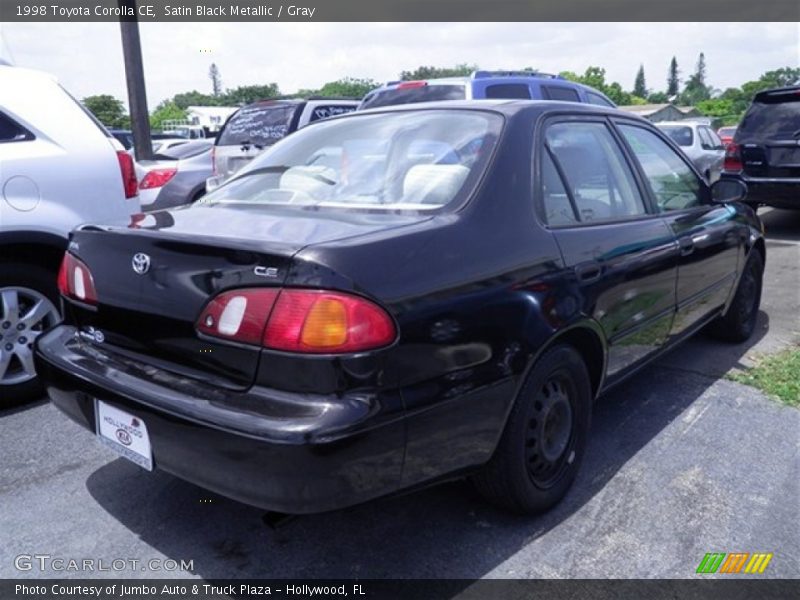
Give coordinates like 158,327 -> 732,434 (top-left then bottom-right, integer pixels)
0,287 -> 60,385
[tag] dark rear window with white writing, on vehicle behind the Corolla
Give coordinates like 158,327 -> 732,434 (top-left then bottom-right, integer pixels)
217,103 -> 300,146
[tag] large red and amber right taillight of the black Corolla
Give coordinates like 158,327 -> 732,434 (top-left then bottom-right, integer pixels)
197,289 -> 397,354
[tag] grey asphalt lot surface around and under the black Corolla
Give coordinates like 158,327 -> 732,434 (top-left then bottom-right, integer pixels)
0,211 -> 800,579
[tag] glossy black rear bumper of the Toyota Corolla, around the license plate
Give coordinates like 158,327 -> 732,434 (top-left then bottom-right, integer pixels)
36,325 -> 405,514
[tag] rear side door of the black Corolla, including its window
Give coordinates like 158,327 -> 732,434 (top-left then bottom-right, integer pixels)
538,117 -> 678,383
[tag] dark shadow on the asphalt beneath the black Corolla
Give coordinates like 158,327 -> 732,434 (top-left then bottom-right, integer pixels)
86,313 -> 768,579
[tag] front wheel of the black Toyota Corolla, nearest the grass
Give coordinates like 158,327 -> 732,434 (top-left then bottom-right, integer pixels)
709,249 -> 764,344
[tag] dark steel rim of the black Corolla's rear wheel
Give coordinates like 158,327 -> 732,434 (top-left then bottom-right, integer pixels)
526,377 -> 574,487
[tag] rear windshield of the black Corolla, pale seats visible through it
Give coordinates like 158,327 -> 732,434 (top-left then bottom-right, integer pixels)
202,110 -> 502,211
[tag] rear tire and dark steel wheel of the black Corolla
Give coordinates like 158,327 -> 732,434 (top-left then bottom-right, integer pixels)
472,345 -> 592,514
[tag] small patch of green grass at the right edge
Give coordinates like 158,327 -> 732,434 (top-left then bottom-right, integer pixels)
728,347 -> 800,408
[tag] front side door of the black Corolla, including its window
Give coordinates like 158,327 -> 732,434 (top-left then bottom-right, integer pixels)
617,121 -> 746,336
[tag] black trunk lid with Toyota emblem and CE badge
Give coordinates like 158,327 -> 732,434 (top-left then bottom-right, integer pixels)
70,206 -> 432,389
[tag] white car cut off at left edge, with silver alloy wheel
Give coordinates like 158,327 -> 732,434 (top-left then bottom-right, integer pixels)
0,63 -> 140,408
